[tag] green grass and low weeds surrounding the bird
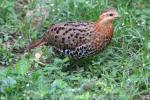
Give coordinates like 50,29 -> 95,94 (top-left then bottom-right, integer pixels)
0,0 -> 150,100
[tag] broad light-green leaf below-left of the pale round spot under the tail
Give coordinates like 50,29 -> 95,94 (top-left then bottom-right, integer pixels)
16,58 -> 31,75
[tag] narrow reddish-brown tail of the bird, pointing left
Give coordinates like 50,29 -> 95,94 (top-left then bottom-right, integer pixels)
25,38 -> 47,51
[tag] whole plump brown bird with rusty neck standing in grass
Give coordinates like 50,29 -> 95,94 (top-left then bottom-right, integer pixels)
26,8 -> 121,59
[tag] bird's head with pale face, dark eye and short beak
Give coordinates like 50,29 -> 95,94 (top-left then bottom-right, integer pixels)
99,8 -> 121,23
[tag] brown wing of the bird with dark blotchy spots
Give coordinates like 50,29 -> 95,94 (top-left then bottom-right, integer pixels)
45,22 -> 94,49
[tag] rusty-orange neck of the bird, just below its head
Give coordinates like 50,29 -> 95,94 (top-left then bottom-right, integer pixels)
95,21 -> 113,36
